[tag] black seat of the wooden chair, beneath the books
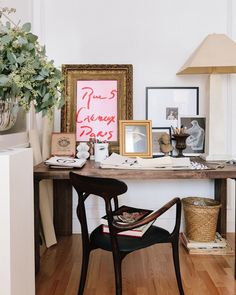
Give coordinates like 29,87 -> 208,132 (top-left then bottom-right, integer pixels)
90,225 -> 170,252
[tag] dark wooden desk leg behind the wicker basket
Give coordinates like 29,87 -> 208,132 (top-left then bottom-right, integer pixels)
215,179 -> 227,238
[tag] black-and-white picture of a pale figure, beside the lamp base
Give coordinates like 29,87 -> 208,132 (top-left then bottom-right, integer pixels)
180,116 -> 206,156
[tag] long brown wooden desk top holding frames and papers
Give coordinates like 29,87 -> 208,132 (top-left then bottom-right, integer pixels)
34,158 -> 236,180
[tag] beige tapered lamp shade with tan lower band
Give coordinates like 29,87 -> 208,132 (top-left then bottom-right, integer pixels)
177,34 -> 236,75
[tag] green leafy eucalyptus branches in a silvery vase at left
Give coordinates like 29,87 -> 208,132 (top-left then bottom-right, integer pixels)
0,8 -> 64,130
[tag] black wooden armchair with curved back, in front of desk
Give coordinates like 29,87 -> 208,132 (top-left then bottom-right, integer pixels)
70,172 -> 184,295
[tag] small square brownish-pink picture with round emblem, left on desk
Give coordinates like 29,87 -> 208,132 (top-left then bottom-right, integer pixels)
51,132 -> 76,157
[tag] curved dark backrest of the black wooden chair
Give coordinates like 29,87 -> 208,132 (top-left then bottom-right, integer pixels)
70,172 -> 127,243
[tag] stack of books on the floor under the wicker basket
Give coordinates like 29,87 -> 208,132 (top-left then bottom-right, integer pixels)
180,233 -> 233,255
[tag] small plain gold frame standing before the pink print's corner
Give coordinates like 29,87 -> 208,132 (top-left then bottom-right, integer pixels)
119,120 -> 152,158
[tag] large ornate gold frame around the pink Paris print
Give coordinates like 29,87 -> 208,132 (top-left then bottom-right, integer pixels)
61,64 -> 133,152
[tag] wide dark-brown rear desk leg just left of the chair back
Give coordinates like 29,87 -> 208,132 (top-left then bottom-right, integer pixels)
53,179 -> 72,236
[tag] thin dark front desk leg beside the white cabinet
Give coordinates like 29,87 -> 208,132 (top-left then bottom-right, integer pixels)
34,180 -> 40,274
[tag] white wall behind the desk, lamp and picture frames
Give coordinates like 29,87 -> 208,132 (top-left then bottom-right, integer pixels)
4,0 -> 236,231
